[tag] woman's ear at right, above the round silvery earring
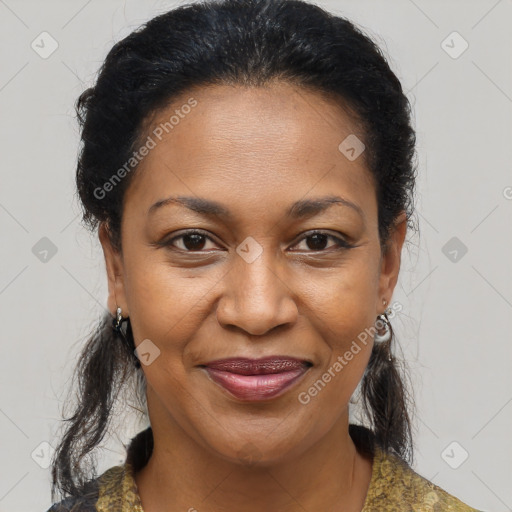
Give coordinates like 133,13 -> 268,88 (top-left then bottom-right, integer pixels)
377,211 -> 407,314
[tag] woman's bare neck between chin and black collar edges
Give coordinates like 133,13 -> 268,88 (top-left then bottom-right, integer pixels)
135,390 -> 372,512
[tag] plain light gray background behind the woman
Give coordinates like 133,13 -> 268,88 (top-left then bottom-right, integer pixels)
0,0 -> 512,512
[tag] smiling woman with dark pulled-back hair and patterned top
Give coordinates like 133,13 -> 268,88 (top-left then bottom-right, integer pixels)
46,0 -> 482,512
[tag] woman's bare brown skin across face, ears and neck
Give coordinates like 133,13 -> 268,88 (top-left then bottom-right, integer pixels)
100,82 -> 406,512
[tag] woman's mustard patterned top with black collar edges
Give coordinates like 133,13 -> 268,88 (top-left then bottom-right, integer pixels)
47,425 -> 479,512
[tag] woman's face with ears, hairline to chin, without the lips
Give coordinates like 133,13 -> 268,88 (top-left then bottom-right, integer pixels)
100,83 -> 406,463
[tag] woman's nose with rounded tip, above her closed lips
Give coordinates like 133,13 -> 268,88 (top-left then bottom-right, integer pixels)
216,250 -> 298,336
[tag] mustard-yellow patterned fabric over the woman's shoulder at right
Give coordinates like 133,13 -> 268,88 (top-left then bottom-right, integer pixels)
363,449 -> 479,512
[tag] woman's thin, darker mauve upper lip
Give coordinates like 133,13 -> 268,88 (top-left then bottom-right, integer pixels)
201,356 -> 312,375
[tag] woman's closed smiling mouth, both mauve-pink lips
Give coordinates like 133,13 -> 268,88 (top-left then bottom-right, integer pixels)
201,356 -> 313,401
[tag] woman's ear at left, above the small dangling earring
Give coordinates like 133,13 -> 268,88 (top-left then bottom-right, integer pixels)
98,222 -> 129,317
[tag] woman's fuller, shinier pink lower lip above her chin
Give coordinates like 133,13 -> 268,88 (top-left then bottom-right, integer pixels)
205,367 -> 309,401
